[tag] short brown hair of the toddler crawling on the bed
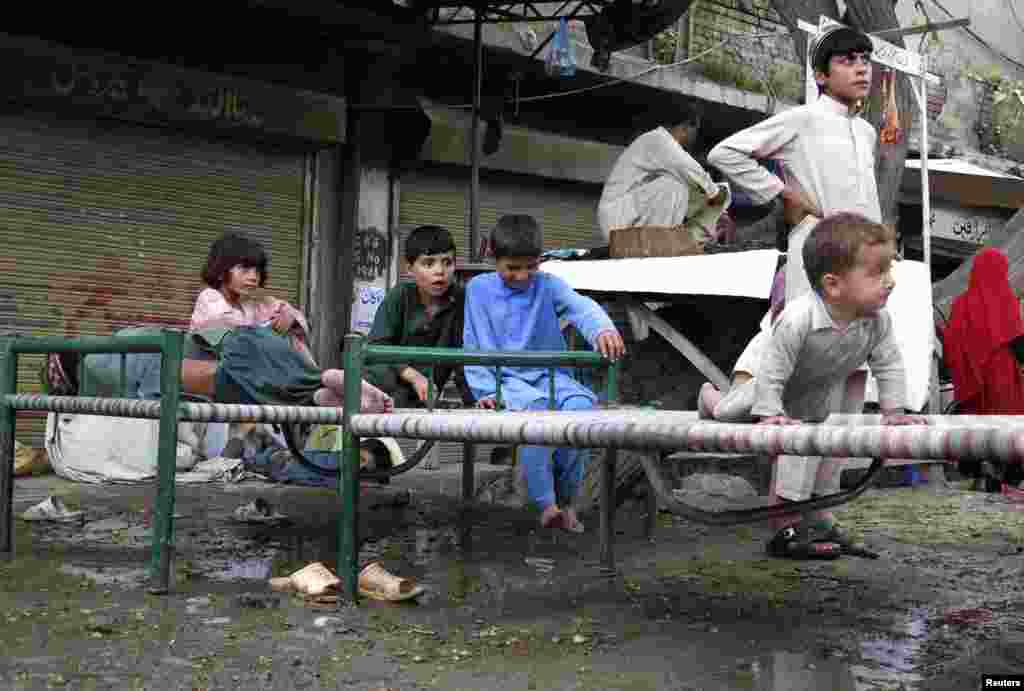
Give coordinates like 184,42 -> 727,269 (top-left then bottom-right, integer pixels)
804,213 -> 896,293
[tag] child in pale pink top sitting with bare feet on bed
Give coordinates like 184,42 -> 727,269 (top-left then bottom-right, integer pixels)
44,233 -> 394,413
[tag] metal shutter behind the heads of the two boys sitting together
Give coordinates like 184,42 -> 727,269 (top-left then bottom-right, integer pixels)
398,166 -> 601,260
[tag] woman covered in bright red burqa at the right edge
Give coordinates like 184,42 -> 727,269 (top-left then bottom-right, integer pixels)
943,248 -> 1024,484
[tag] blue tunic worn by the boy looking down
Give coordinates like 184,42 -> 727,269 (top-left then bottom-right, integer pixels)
463,271 -> 615,411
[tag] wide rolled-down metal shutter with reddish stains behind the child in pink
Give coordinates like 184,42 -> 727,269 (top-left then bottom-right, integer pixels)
0,117 -> 304,445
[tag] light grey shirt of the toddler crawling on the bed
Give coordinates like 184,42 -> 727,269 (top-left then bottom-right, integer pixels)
751,293 -> 906,420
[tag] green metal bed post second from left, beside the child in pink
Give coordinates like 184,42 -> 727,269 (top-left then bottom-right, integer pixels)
149,330 -> 184,595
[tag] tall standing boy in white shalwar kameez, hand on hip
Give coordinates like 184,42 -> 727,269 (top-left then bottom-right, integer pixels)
708,27 -> 882,552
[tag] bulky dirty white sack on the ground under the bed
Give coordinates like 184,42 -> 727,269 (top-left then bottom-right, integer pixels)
46,413 -> 206,484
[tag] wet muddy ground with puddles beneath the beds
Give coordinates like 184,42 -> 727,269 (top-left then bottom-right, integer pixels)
0,471 -> 1024,691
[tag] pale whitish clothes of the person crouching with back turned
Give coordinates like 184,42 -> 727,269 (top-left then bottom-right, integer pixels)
597,127 -> 731,245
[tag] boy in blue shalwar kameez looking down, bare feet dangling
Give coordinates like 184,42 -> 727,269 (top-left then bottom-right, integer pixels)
463,215 -> 626,532
